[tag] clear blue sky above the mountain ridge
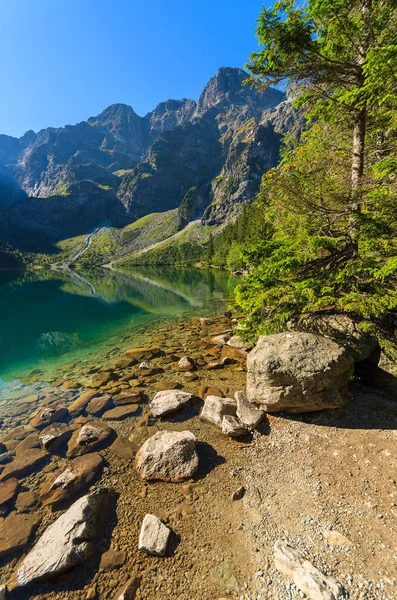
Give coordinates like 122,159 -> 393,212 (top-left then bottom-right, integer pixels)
0,0 -> 270,136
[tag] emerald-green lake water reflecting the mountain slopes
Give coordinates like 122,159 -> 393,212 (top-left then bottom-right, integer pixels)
0,267 -> 237,380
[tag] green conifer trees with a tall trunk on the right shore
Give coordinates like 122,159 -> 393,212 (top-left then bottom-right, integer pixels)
234,0 -> 397,351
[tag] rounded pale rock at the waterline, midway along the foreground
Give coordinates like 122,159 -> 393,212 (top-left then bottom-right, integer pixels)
136,431 -> 199,481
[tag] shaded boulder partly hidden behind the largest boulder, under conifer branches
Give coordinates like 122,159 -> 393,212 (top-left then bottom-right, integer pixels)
288,313 -> 380,364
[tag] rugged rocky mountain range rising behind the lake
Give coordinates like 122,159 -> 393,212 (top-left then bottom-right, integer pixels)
0,67 -> 302,258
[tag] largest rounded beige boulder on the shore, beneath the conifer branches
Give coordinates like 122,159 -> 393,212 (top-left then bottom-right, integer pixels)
247,333 -> 353,413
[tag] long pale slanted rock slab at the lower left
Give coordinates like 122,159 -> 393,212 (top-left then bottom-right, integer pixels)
17,491 -> 105,586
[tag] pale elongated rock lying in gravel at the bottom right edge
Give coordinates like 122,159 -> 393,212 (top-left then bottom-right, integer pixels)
274,540 -> 344,600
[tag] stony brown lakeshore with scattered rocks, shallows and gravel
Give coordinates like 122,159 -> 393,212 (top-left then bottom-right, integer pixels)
0,316 -> 397,600
